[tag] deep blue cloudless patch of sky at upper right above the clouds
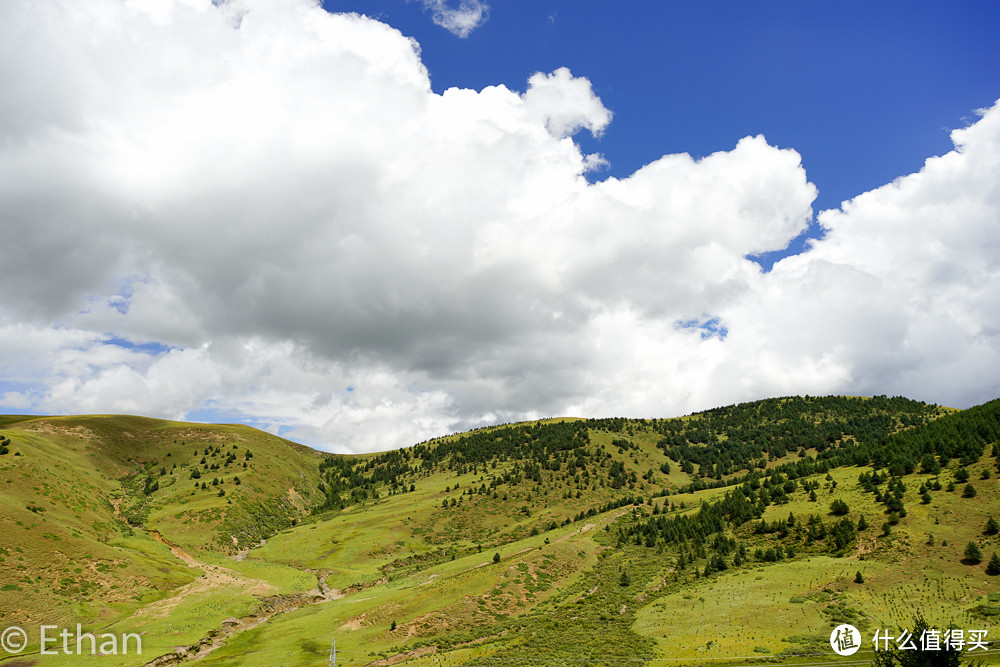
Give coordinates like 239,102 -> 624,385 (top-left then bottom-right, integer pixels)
324,0 -> 1000,264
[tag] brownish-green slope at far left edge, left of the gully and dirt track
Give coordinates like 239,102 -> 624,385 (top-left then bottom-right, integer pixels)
0,419 -> 194,636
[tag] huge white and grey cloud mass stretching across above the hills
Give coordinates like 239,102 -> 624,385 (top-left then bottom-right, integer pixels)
0,0 -> 1000,451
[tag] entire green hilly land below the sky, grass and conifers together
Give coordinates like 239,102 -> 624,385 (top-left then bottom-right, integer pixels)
0,396 -> 1000,666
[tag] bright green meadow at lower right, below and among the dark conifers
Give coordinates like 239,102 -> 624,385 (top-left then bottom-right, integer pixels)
635,457 -> 1000,660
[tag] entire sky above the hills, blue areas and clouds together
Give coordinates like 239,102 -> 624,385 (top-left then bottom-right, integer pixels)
0,0 -> 1000,452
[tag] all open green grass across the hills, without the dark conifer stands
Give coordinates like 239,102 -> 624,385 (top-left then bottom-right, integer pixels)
0,400 -> 1000,665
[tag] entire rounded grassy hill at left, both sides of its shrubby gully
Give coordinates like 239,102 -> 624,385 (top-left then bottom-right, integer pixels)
0,416 -> 321,664
